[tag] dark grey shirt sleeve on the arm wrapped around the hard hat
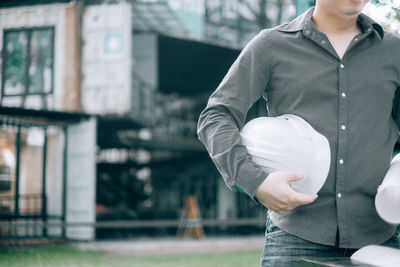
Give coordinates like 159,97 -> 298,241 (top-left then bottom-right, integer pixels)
197,30 -> 270,200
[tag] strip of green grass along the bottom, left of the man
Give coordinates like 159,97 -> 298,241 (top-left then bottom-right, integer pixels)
0,245 -> 261,267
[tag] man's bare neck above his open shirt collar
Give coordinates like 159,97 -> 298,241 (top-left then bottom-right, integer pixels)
312,5 -> 359,34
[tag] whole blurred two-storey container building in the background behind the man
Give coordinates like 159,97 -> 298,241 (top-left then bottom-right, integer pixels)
0,0 -> 309,242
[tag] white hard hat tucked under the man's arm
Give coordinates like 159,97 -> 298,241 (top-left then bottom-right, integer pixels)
240,114 -> 331,195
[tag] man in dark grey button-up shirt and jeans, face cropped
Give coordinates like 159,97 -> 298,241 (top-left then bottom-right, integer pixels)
198,0 -> 400,266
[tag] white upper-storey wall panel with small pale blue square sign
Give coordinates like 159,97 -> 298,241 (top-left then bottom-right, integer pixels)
81,3 -> 132,114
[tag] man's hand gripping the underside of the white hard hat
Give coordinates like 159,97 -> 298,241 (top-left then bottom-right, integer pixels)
255,172 -> 318,214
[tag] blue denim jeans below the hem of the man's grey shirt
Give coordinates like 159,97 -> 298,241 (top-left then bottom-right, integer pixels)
261,217 -> 399,267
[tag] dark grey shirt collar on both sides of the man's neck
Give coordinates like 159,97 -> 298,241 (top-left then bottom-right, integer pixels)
277,7 -> 384,39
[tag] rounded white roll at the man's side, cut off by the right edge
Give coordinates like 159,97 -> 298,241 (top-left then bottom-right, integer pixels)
375,154 -> 400,224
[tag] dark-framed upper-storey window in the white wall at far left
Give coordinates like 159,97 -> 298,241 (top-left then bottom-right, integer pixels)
1,27 -> 54,100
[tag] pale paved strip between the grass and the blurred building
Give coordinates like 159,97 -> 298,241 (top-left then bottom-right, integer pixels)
77,236 -> 264,256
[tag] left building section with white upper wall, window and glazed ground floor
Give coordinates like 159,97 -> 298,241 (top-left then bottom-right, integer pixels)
0,1 -> 96,242
